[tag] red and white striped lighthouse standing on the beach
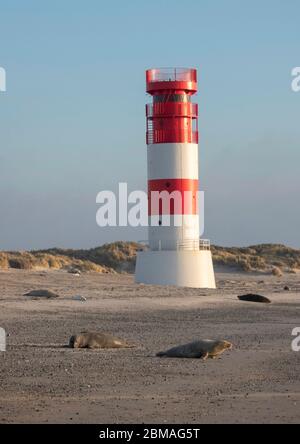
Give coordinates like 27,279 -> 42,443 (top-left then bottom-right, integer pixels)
135,68 -> 216,288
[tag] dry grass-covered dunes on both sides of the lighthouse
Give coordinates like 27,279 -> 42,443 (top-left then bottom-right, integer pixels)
0,242 -> 300,276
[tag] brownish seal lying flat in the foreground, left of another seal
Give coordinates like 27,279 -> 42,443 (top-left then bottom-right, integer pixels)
69,332 -> 133,348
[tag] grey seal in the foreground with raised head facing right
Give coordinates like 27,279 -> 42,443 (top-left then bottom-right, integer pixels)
156,339 -> 232,360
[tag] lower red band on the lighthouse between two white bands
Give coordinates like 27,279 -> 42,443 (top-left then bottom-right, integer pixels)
148,179 -> 199,216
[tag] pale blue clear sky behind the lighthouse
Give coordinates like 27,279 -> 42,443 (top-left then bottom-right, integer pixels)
0,0 -> 300,249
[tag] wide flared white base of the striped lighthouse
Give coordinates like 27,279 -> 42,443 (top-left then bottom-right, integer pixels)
135,250 -> 216,288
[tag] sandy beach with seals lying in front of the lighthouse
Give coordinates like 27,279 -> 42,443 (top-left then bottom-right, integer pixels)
0,270 -> 300,424
